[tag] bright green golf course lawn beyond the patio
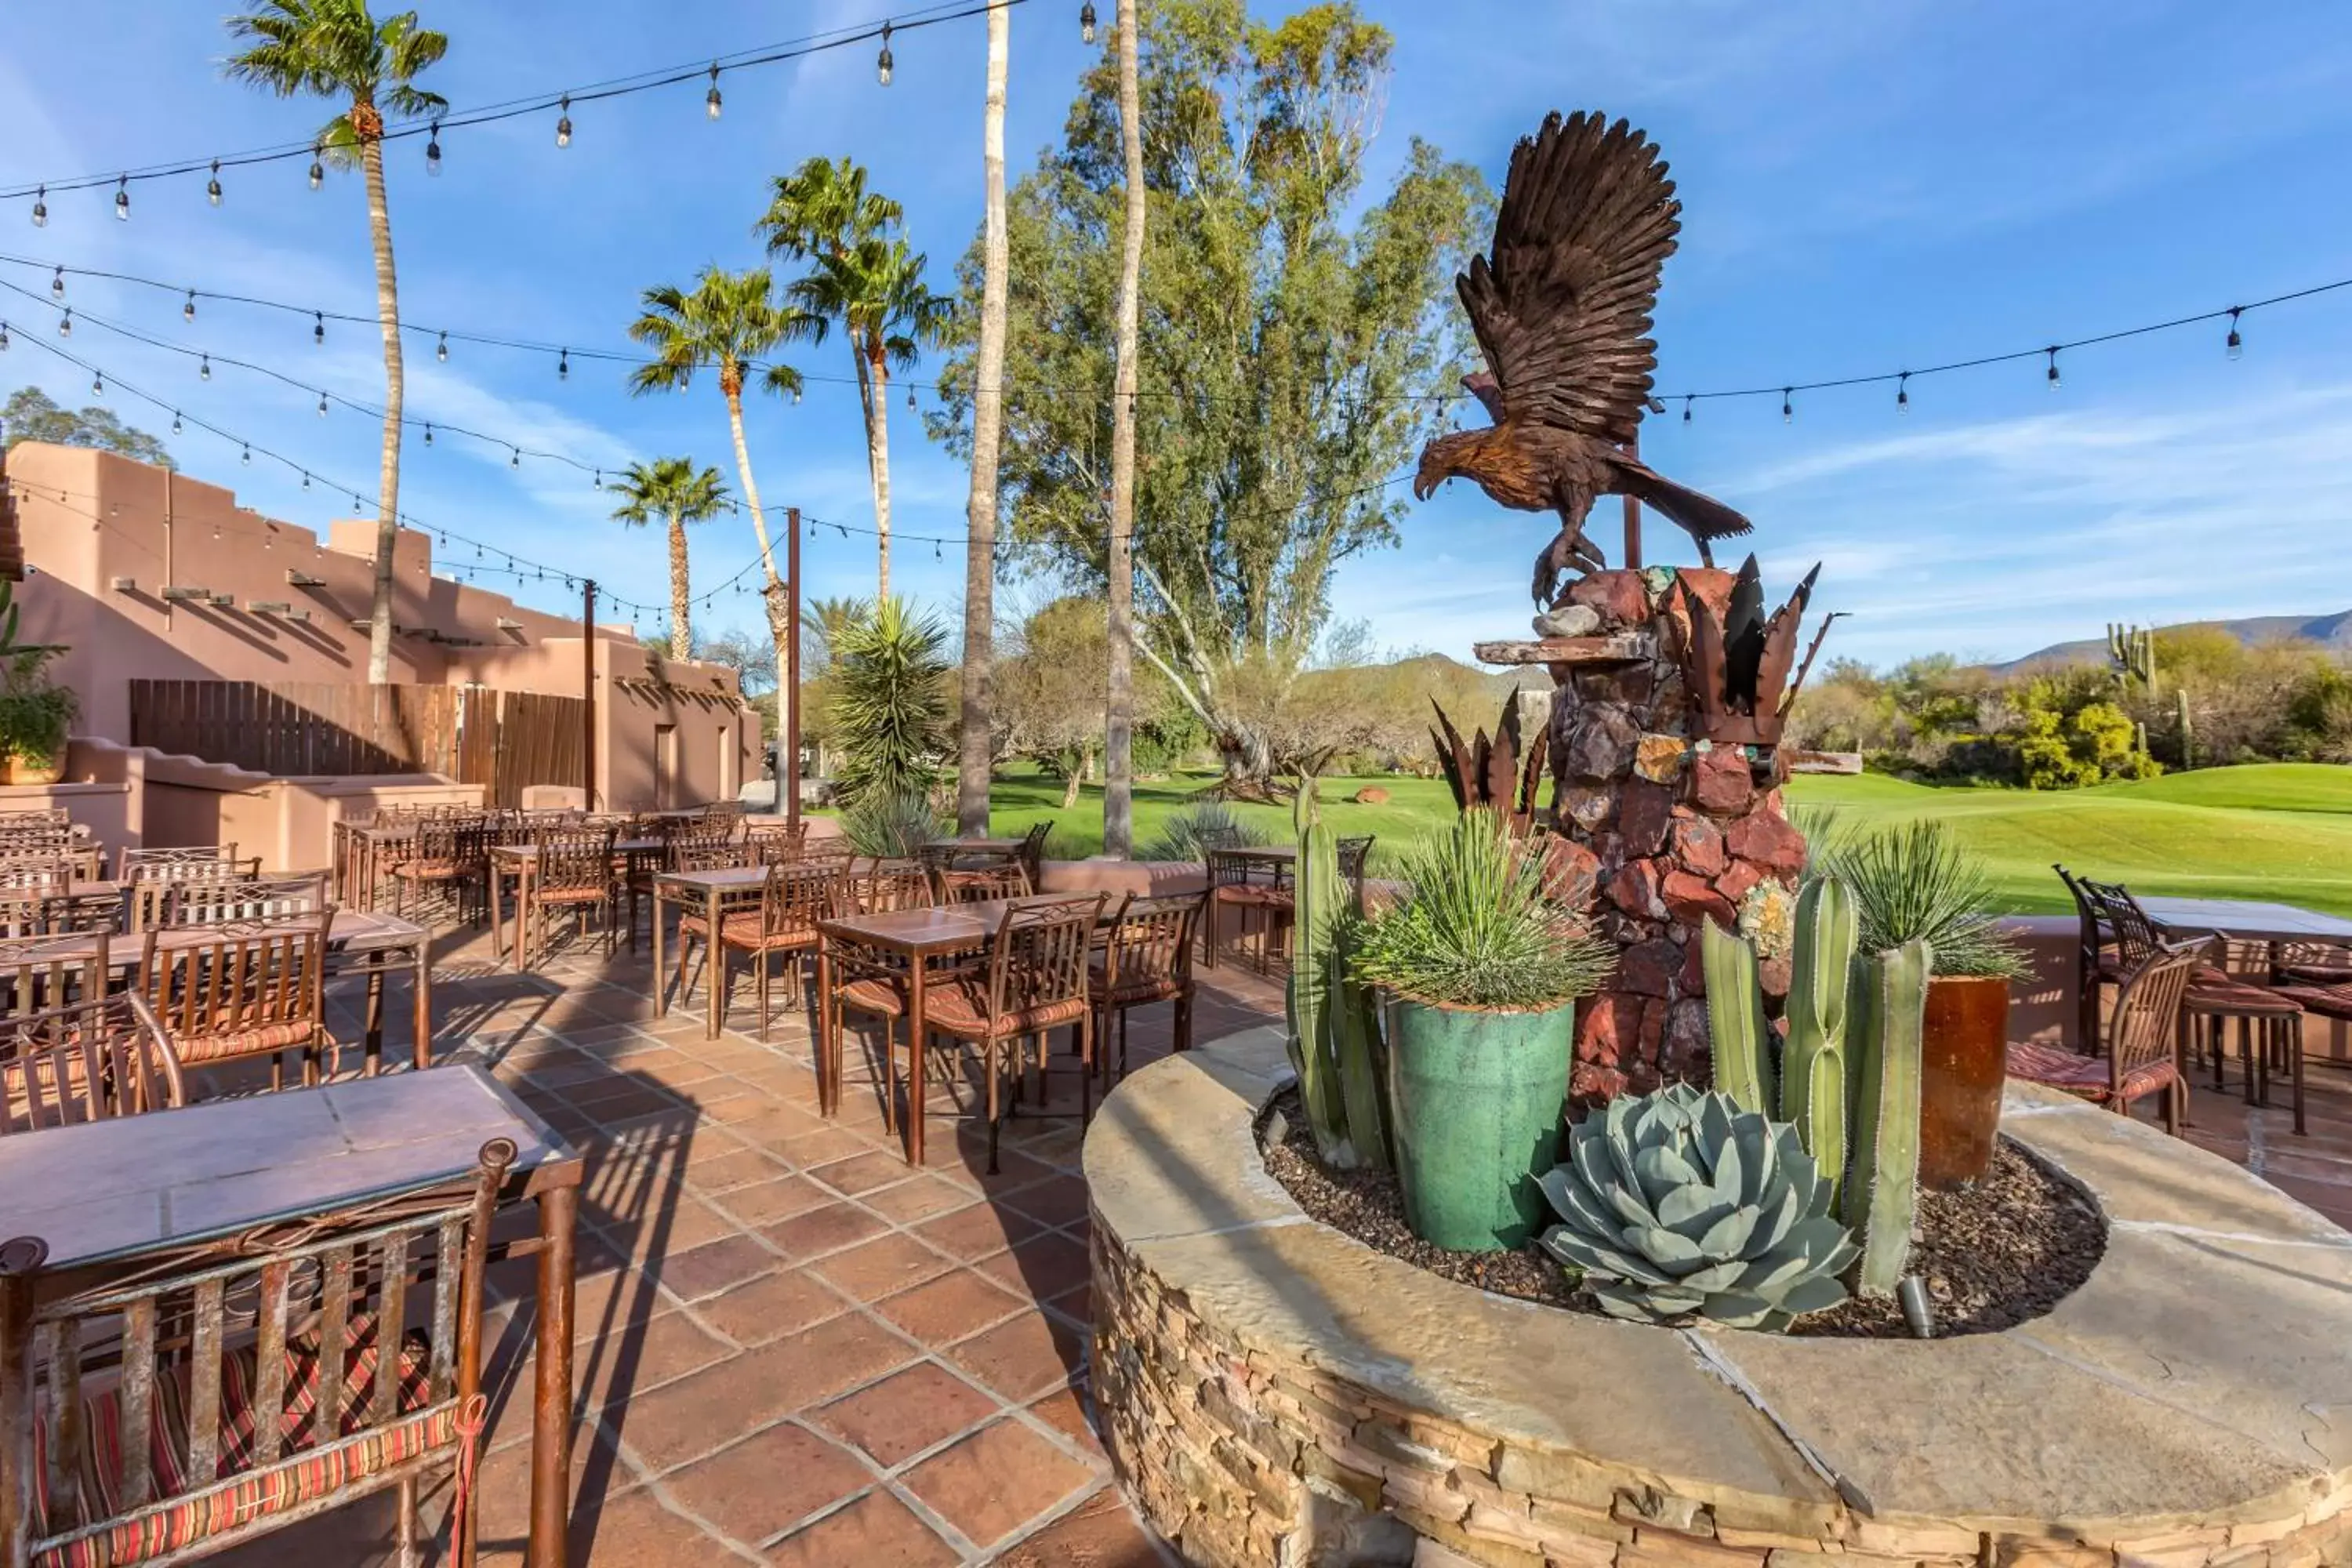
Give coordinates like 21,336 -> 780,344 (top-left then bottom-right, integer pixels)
995,762 -> 2352,914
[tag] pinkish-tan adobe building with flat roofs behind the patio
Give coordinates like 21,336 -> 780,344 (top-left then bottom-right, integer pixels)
0,442 -> 760,865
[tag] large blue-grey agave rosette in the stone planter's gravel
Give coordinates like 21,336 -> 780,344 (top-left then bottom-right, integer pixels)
1543,1083 -> 1858,1330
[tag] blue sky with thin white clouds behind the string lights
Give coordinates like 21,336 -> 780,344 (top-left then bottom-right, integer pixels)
0,0 -> 2352,661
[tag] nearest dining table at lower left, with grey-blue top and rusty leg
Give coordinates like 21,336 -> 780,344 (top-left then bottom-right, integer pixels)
0,1065 -> 581,1568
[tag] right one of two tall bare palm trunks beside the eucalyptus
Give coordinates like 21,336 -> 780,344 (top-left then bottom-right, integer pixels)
1103,0 -> 1143,860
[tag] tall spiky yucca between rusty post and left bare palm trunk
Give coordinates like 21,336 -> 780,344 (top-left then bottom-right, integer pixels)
826,600 -> 948,806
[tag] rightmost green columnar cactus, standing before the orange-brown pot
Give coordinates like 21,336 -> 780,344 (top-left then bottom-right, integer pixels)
1839,940 -> 1929,1295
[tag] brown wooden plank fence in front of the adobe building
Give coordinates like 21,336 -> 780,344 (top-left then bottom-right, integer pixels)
129,680 -> 588,806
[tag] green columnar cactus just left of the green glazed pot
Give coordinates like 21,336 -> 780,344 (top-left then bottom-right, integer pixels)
1287,779 -> 1388,1171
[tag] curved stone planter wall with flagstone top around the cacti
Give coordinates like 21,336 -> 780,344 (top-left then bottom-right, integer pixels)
1087,1029 -> 2352,1568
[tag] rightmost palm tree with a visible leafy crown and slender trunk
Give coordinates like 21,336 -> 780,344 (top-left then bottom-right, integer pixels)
786,235 -> 953,597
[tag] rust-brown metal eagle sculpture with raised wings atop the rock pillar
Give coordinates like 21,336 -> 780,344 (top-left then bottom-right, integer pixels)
1414,113 -> 1750,604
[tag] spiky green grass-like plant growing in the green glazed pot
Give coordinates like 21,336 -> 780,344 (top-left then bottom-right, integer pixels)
1355,811 -> 1616,1011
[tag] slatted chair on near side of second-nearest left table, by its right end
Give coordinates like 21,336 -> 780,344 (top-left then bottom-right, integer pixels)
139,909 -> 334,1088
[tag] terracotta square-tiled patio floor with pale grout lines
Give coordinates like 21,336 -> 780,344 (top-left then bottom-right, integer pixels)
198,912 -> 2352,1568
